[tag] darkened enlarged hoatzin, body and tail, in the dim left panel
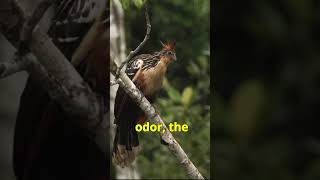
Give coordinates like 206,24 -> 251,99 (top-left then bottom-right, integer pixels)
13,0 -> 110,180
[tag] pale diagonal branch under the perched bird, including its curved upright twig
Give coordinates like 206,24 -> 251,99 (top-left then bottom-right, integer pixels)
110,3 -> 204,179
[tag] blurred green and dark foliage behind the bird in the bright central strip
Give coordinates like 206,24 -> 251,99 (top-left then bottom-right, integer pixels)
117,0 -> 210,179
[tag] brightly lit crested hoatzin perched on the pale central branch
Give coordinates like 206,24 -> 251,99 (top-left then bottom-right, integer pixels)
112,42 -> 176,167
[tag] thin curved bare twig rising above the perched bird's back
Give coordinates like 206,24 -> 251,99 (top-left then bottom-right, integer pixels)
115,3 -> 151,79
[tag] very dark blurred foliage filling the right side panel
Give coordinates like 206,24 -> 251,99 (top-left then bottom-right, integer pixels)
212,0 -> 320,180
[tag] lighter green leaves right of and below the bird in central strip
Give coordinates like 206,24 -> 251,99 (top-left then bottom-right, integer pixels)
138,45 -> 210,178
